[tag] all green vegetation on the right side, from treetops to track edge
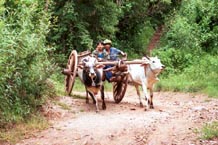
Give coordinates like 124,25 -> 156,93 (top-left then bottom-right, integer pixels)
153,0 -> 218,97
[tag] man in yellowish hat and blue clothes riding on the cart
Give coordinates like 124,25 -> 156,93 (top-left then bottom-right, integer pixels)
103,39 -> 126,82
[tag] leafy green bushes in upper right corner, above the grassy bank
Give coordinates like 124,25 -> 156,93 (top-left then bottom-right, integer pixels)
165,0 -> 218,54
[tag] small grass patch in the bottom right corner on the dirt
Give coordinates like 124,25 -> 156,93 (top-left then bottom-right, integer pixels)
201,121 -> 218,140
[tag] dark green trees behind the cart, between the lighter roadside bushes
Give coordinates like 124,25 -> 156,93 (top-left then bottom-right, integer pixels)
48,0 -> 180,65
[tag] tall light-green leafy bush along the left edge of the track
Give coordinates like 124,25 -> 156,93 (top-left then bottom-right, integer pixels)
0,1 -> 54,125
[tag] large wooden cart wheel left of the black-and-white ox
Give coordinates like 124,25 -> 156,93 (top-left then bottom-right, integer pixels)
65,50 -> 78,95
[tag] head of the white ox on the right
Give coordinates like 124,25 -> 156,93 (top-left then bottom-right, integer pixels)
142,56 -> 165,74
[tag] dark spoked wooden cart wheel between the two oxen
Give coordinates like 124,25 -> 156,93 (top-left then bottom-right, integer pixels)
113,74 -> 128,103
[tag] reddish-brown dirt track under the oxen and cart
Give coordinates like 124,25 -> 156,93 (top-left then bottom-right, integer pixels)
17,87 -> 218,145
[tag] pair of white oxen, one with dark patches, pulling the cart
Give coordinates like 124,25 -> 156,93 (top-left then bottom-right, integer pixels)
77,56 -> 165,112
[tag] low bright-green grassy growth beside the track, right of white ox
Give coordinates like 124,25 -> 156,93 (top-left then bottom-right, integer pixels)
157,54 -> 218,97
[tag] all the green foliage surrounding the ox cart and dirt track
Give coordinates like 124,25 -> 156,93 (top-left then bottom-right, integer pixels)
0,0 -> 218,128
